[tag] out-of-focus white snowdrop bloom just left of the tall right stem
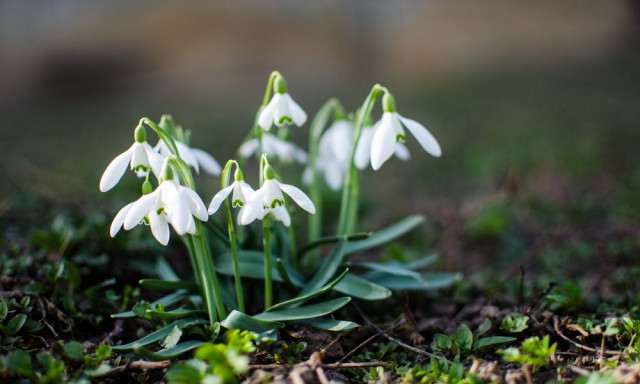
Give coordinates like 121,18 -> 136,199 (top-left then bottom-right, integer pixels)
303,119 -> 353,191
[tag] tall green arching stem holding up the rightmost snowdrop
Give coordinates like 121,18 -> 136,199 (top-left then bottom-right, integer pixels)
338,84 -> 385,235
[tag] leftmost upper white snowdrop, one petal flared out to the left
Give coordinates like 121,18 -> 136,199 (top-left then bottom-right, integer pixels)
100,125 -> 163,192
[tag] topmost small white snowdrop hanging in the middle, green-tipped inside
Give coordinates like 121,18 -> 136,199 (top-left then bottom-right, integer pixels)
258,75 -> 307,131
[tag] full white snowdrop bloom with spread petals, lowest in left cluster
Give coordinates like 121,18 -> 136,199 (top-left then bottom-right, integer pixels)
110,163 -> 209,245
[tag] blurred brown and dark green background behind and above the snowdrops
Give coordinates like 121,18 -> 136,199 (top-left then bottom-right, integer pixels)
0,0 -> 640,254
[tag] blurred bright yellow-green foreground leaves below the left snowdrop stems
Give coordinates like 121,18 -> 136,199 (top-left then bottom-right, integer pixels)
167,330 -> 256,384
